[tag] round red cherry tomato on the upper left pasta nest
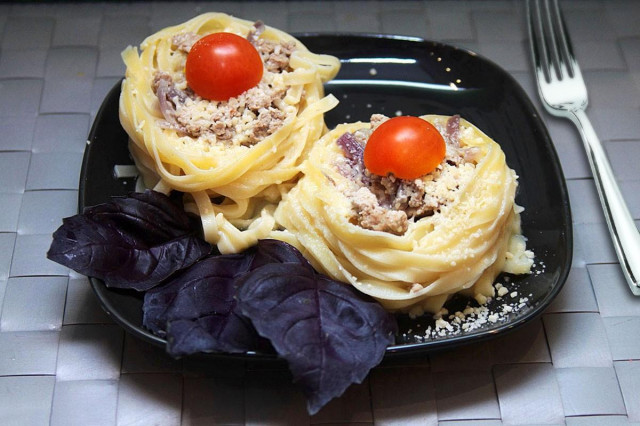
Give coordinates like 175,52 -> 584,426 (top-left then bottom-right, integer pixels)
185,32 -> 263,101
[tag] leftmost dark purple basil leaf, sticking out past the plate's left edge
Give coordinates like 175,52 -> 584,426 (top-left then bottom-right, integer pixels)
47,191 -> 211,291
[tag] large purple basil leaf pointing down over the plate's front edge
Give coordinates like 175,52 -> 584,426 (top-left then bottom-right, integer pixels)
237,263 -> 397,414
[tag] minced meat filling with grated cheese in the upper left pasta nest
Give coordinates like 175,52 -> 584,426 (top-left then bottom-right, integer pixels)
152,23 -> 296,145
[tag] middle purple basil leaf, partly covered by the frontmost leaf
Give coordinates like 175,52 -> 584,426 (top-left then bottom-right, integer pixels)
142,254 -> 261,357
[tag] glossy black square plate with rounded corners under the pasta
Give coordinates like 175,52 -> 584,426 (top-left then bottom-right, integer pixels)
79,34 -> 572,359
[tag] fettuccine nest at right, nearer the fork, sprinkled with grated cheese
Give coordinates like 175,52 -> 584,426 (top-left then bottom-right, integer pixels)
275,115 -> 533,315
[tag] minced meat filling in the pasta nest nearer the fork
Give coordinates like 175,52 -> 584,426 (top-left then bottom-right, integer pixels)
337,114 -> 479,235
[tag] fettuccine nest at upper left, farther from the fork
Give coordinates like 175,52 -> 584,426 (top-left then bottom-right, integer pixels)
120,13 -> 340,253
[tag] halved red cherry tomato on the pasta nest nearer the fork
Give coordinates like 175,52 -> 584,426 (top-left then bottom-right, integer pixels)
364,116 -> 446,179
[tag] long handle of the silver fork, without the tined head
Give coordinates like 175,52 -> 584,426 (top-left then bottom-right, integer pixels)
570,110 -> 640,296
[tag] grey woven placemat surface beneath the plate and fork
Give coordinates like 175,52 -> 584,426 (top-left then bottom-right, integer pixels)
0,0 -> 640,426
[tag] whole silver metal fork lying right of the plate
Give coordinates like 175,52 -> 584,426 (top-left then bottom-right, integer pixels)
527,0 -> 640,296
